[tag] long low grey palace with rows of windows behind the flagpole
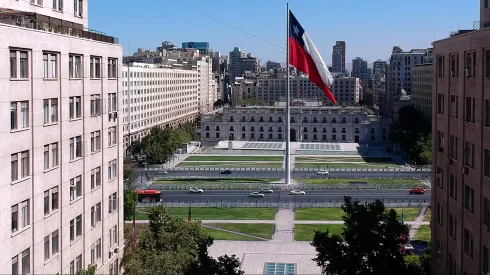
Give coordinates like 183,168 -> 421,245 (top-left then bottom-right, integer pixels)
201,106 -> 391,144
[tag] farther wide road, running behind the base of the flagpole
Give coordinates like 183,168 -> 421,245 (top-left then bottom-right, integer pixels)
145,170 -> 431,180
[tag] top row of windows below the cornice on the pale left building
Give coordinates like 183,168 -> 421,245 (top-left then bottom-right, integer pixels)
10,49 -> 118,79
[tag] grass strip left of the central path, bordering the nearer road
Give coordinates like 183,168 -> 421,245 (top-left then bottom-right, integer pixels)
136,207 -> 276,220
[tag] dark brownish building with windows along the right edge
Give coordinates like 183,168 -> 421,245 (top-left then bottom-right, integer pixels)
431,0 -> 490,274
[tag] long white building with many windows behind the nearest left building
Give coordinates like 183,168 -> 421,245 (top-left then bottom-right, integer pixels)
122,63 -> 199,150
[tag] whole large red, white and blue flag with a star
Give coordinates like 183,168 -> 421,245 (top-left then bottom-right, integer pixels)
288,12 -> 337,103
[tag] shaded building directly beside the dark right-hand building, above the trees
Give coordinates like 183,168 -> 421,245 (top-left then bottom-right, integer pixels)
412,64 -> 434,121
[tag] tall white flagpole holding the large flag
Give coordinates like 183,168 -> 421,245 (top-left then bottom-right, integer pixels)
284,3 -> 291,184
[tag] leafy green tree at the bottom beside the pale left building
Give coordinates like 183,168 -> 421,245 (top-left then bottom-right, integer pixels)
124,205 -> 243,275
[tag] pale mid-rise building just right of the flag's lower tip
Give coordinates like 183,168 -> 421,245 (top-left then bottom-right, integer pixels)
332,77 -> 361,104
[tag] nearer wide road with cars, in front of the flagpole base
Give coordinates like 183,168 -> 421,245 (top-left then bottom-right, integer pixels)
162,190 -> 431,205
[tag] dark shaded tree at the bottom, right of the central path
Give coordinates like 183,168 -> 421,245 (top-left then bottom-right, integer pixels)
312,197 -> 408,275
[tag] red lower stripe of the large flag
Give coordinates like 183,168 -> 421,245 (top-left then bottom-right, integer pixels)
289,37 -> 337,103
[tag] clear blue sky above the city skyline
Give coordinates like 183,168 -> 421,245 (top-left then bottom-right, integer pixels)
88,0 -> 480,64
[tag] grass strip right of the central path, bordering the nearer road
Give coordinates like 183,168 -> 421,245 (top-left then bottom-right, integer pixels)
294,208 -> 420,221
